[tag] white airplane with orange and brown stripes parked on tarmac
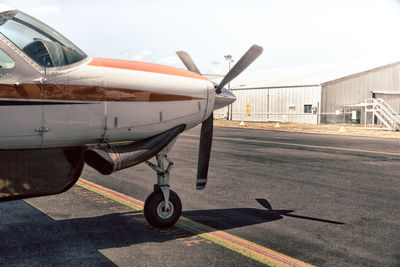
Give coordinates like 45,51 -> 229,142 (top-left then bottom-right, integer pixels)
0,5 -> 263,228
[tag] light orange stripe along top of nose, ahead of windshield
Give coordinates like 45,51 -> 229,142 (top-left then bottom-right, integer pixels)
88,58 -> 207,81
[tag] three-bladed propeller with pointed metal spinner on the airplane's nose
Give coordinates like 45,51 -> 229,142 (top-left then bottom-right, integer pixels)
176,45 -> 263,190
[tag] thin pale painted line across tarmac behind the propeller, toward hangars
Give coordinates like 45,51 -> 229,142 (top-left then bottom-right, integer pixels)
181,134 -> 400,156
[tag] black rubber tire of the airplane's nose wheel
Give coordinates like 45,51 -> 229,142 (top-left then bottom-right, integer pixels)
144,190 -> 182,228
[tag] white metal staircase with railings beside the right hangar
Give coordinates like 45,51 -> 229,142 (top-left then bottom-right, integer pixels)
365,98 -> 400,131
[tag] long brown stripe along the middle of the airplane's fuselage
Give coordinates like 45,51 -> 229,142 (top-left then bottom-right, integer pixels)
0,84 -> 205,102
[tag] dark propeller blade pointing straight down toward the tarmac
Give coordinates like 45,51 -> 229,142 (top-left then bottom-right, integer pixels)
196,113 -> 214,190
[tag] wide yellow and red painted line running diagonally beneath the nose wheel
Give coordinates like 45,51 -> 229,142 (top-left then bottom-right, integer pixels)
77,178 -> 312,267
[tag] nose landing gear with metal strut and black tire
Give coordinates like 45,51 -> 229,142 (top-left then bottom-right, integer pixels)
144,152 -> 182,228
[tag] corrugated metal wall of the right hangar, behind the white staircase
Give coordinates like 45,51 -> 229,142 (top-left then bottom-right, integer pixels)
321,62 -> 400,123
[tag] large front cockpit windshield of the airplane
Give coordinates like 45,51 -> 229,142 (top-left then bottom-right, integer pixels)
0,10 -> 87,67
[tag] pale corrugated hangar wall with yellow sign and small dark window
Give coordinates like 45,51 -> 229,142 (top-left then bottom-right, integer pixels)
215,86 -> 321,124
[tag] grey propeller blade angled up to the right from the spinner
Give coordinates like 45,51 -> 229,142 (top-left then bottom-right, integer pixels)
215,45 -> 263,94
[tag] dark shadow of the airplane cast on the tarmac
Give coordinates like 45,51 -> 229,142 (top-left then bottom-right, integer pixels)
0,199 -> 343,266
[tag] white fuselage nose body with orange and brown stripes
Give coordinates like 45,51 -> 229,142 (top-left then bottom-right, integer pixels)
0,58 -> 215,149
